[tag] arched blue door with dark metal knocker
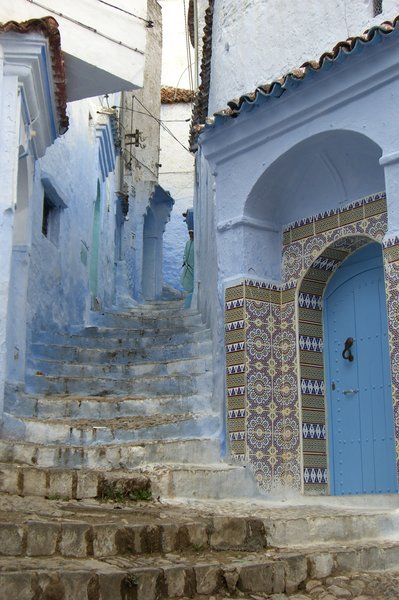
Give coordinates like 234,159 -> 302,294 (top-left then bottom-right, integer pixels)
324,243 -> 397,495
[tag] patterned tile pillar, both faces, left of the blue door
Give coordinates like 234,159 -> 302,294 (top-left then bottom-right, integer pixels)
225,279 -> 301,491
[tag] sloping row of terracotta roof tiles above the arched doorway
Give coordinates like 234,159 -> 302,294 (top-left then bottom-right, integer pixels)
198,15 -> 399,137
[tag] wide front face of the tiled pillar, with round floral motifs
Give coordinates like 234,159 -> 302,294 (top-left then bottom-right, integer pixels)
245,290 -> 301,491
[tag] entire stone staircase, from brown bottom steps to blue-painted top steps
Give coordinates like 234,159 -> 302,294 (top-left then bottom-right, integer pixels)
0,302 -> 399,600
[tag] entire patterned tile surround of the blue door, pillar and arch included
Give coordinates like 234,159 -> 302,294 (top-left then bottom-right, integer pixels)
225,193 -> 399,494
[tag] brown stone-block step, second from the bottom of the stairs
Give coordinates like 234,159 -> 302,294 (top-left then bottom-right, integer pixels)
0,510 -> 267,558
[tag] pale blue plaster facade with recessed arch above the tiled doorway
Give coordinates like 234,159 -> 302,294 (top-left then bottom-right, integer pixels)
195,33 -> 399,474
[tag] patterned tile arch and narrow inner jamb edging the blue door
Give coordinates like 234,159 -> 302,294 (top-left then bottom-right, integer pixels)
290,194 -> 399,494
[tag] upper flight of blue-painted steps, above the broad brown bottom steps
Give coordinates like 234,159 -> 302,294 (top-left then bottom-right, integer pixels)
0,301 -> 257,499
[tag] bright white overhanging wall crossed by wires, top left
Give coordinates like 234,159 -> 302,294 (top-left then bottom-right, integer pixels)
0,0 -> 149,101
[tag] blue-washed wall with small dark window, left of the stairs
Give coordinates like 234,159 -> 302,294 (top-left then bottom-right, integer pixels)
3,99 -> 121,390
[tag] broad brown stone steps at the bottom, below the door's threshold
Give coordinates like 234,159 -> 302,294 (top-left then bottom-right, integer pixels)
0,495 -> 399,600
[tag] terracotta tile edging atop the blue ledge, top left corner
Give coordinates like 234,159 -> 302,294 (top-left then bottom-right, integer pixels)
0,17 -> 69,134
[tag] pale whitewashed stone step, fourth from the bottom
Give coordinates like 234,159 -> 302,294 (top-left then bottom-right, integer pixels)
0,437 -> 220,471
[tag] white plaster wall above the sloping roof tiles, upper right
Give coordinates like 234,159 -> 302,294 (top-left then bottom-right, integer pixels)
209,0 -> 399,114
